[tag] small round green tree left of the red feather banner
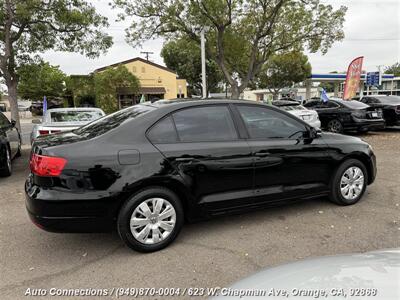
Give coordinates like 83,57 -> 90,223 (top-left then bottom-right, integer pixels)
258,51 -> 311,99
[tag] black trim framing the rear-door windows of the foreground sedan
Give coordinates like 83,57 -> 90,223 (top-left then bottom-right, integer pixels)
145,103 -> 243,145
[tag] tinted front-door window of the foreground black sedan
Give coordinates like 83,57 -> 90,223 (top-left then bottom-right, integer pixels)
238,105 -> 305,139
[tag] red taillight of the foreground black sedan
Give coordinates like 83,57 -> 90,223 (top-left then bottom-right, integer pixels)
30,154 -> 67,176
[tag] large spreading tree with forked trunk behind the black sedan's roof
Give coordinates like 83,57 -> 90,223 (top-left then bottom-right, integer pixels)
114,0 -> 346,98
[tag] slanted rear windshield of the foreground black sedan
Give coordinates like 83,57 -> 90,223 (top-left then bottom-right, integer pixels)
73,104 -> 155,138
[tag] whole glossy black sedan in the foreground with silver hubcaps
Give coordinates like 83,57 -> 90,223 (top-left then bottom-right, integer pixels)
25,100 -> 376,252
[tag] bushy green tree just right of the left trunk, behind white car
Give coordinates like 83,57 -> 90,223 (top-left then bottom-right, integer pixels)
17,62 -> 66,100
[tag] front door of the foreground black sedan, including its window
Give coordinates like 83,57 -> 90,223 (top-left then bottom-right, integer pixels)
236,104 -> 331,204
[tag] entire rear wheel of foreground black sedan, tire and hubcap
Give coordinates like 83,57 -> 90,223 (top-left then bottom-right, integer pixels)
117,187 -> 184,252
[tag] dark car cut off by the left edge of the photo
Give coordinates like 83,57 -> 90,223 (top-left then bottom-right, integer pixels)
0,112 -> 21,176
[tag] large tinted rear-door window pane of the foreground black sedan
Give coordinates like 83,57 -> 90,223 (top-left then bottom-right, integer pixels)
173,105 -> 238,142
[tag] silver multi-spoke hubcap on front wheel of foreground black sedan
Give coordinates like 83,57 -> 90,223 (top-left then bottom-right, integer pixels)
340,166 -> 364,200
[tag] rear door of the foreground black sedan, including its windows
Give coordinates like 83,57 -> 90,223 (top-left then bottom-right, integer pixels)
148,104 -> 254,213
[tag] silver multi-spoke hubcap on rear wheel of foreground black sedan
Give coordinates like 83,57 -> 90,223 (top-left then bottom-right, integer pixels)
130,198 -> 176,245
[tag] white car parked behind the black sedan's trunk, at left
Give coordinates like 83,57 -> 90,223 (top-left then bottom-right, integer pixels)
31,107 -> 106,143
